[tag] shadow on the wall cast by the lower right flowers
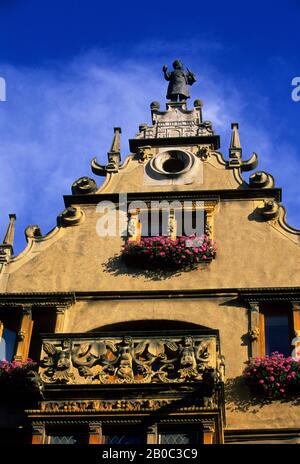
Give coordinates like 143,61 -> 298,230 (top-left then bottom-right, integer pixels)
225,376 -> 300,414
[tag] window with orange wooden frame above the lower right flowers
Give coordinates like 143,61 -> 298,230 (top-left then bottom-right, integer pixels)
260,304 -> 292,356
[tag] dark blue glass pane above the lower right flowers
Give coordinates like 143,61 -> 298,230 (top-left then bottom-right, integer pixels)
265,314 -> 291,356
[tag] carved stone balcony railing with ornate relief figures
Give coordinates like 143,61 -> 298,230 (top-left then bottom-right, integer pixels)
39,331 -> 224,387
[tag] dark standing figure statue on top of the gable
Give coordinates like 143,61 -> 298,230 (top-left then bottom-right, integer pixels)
163,60 -> 196,102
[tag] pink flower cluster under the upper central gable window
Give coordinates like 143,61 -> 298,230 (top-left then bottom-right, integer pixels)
122,235 -> 216,269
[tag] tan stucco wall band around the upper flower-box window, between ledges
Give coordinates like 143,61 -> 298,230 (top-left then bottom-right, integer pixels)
7,200 -> 300,292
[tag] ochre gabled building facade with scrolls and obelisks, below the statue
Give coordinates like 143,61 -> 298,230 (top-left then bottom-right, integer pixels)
0,68 -> 300,444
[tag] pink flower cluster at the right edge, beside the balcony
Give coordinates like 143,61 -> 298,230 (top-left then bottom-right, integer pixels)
243,351 -> 300,399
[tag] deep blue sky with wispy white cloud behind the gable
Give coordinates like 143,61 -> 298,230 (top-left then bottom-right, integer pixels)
0,0 -> 300,252
